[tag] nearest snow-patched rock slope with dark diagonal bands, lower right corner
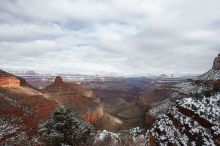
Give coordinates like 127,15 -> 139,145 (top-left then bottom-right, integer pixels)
145,95 -> 220,146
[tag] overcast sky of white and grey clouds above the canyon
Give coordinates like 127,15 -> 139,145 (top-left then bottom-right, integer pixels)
0,0 -> 220,75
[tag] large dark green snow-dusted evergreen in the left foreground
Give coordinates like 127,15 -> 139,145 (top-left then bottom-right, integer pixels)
39,107 -> 93,146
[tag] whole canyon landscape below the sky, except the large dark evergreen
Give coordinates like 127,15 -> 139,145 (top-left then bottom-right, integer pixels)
0,55 -> 220,146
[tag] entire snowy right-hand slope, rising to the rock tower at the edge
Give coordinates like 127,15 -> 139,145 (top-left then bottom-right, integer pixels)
144,55 -> 220,146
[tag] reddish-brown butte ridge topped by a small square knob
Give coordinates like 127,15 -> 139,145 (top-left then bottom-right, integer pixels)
44,76 -> 103,125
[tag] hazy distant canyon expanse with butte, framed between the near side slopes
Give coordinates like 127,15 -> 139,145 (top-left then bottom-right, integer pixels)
12,71 -> 189,132
